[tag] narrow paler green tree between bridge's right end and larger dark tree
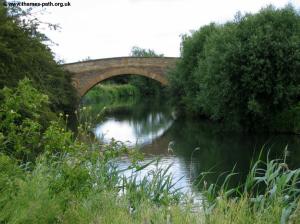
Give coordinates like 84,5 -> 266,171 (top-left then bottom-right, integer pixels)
168,23 -> 217,114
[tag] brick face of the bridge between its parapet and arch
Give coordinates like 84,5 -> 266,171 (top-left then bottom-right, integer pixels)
73,67 -> 168,97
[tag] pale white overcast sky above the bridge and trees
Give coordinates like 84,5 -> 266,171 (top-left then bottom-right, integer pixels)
32,0 -> 300,62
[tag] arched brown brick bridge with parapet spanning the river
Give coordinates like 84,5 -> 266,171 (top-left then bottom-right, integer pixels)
63,57 -> 178,97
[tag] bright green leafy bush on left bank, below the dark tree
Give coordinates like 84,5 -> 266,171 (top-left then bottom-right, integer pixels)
0,79 -> 80,162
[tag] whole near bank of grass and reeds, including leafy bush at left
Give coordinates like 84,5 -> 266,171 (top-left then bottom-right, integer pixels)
0,80 -> 300,224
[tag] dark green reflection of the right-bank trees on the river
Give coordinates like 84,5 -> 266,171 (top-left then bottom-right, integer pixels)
164,120 -> 300,186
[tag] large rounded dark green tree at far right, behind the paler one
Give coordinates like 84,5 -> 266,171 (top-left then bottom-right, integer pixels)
196,6 -> 300,130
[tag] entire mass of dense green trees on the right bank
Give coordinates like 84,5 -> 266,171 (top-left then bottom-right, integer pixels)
170,5 -> 300,132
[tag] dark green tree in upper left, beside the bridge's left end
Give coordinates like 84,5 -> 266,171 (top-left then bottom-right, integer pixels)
0,0 -> 76,113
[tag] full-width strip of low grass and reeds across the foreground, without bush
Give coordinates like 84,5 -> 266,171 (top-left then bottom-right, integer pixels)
0,148 -> 300,224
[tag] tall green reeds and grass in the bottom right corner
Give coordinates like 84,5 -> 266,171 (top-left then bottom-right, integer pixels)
198,148 -> 300,223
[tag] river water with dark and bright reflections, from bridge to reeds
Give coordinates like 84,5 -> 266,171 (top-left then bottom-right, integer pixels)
85,99 -> 300,194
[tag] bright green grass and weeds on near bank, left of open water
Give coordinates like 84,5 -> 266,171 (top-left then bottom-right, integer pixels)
0,151 -> 200,223
